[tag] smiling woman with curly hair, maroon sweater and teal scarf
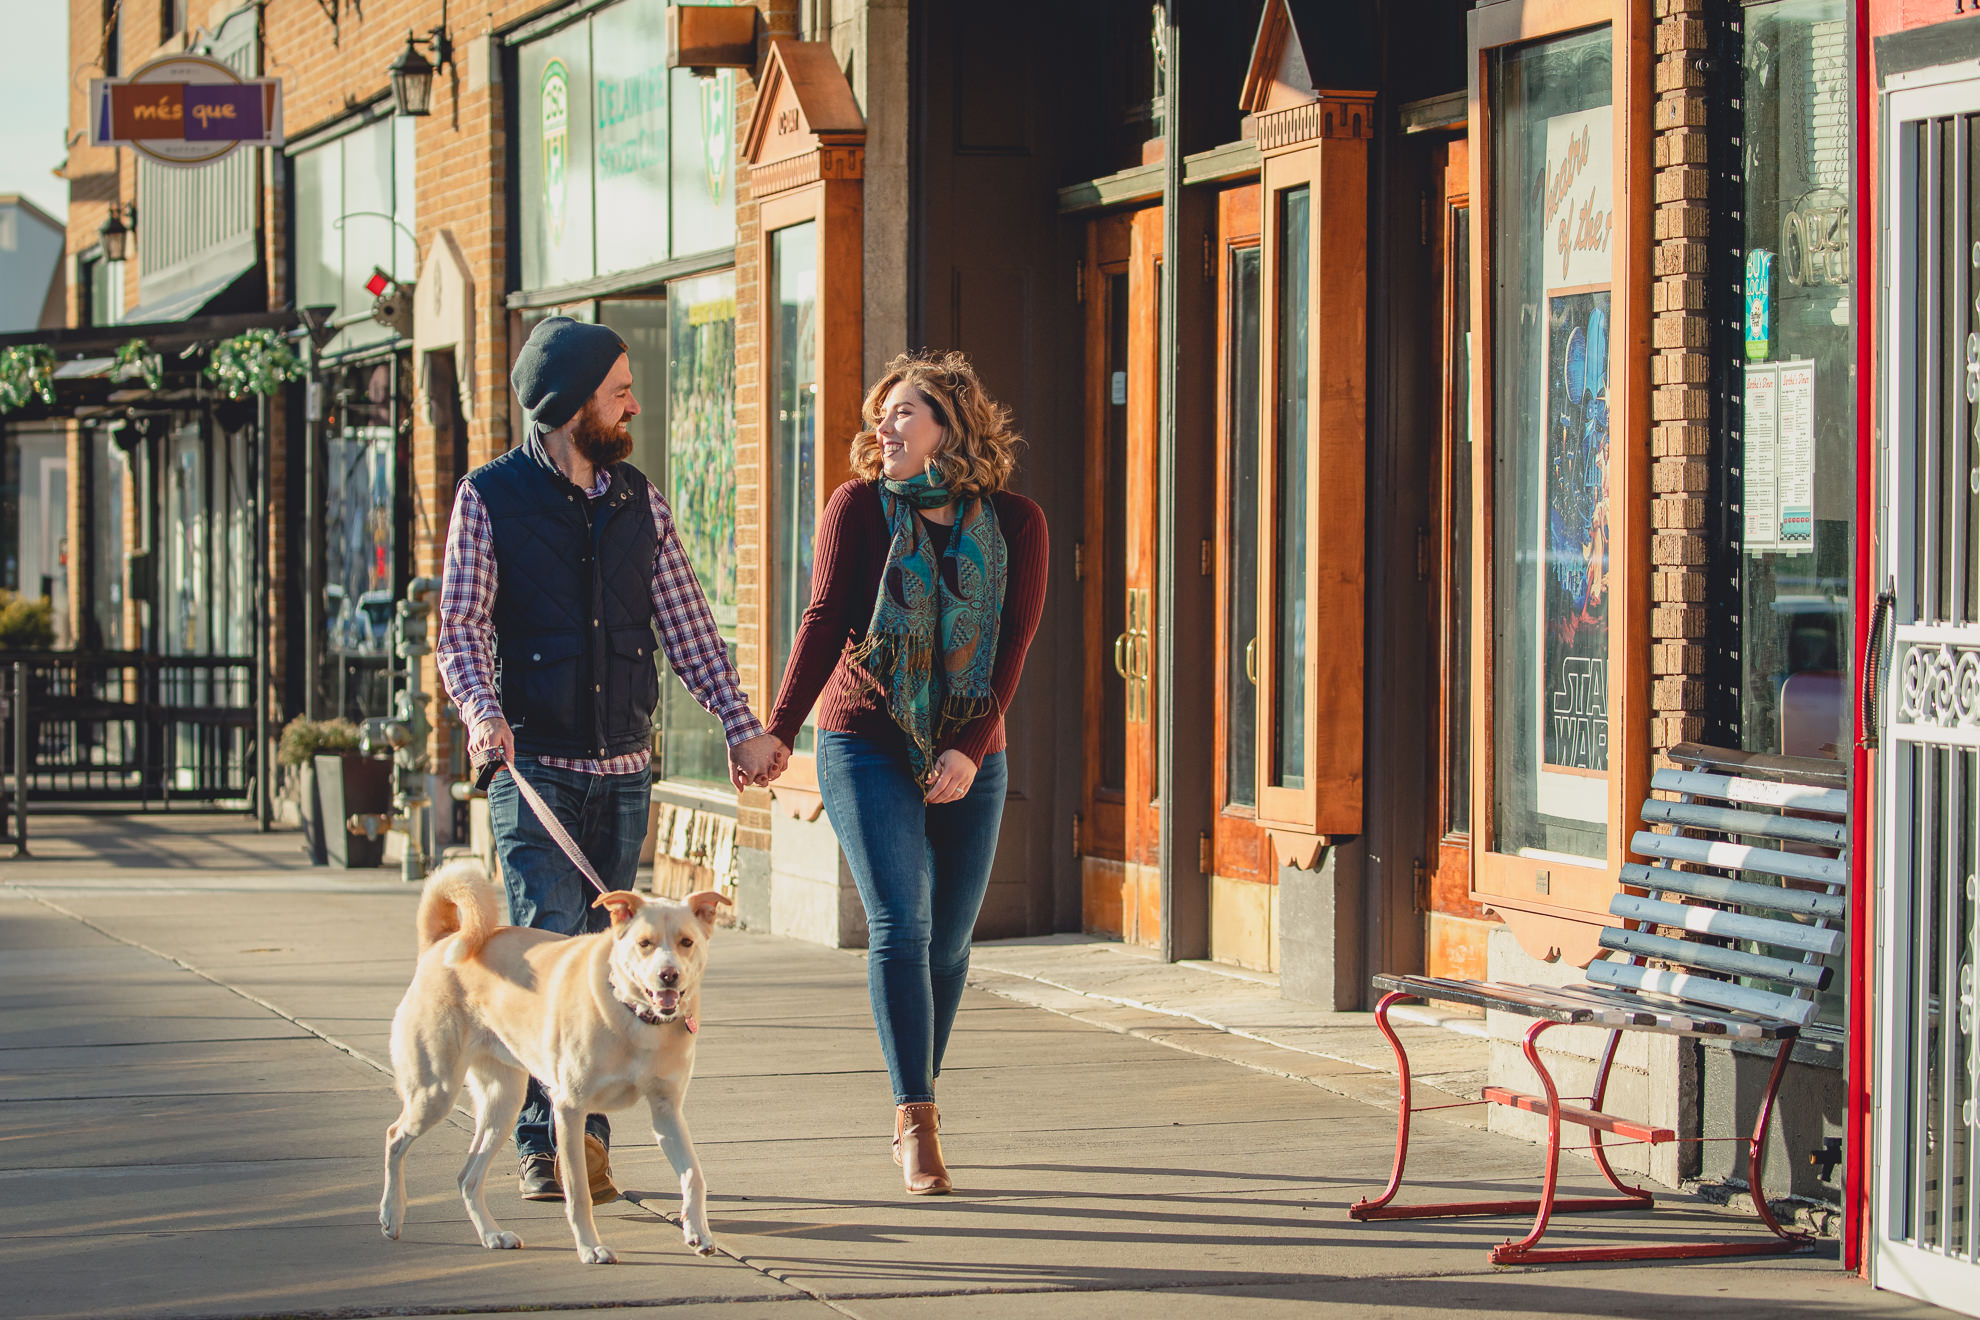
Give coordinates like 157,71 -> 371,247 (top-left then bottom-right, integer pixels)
770,352 -> 1045,1195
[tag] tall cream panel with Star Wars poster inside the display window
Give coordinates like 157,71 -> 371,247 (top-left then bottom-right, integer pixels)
1535,105 -> 1616,821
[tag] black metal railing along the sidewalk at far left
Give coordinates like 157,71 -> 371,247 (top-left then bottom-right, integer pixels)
0,651 -> 255,847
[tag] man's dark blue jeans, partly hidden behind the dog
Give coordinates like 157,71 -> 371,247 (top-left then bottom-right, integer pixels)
489,756 -> 653,1156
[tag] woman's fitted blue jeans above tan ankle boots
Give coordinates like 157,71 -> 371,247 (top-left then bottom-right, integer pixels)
818,728 -> 1008,1104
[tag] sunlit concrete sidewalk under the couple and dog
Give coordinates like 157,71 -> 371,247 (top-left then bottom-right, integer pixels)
0,825 -> 1946,1320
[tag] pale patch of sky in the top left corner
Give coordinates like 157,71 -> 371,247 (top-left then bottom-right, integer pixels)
0,0 -> 73,220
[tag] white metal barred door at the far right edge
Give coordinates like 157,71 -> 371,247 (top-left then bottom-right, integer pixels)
1871,81 -> 1980,1314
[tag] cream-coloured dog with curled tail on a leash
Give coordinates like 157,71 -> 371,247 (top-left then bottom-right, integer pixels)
378,861 -> 729,1265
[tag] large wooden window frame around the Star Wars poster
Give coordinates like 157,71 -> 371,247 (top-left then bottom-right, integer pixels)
1467,0 -> 1653,953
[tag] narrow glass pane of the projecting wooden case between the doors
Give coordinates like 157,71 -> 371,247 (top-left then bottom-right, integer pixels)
1271,188 -> 1313,788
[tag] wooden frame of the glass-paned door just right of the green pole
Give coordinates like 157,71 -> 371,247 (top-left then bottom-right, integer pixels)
1212,184 -> 1277,886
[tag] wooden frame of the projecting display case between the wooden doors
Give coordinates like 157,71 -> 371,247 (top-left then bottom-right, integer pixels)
1257,93 -> 1374,835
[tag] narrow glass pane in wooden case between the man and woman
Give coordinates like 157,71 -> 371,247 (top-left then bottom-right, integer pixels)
766,220 -> 818,752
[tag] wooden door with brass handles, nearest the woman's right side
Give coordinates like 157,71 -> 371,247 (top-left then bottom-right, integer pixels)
1079,208 -> 1162,944
